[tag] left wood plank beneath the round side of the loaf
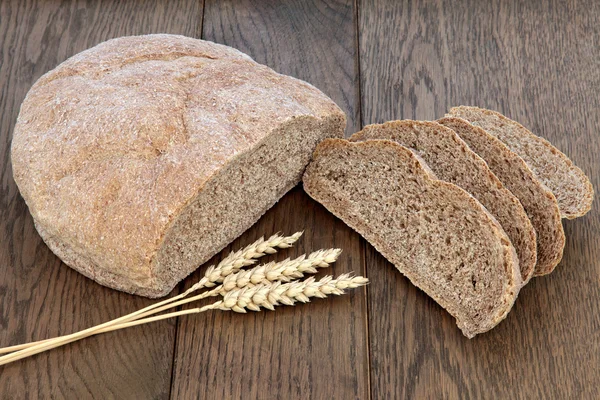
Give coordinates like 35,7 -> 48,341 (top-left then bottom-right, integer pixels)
0,0 -> 202,398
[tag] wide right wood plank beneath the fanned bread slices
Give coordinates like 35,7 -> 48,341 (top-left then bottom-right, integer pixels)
359,0 -> 600,399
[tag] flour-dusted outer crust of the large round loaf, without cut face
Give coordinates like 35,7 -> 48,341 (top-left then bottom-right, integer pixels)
11,35 -> 344,292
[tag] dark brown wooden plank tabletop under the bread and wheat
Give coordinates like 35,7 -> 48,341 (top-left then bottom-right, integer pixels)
0,0 -> 600,399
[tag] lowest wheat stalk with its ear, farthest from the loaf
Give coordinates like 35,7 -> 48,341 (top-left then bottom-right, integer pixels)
0,274 -> 368,365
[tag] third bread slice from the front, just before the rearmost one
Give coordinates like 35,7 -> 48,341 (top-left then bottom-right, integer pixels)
438,117 -> 565,276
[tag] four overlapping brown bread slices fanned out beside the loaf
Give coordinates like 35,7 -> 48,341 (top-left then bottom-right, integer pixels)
303,106 -> 594,337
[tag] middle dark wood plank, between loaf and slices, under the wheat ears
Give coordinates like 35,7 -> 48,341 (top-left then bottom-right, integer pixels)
172,1 -> 368,399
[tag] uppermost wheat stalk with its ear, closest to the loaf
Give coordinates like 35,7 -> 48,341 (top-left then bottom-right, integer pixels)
0,232 -> 303,354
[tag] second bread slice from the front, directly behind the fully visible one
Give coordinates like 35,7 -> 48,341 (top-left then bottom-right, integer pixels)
350,120 -> 537,283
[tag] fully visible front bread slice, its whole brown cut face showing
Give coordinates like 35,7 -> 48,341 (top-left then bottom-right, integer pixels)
303,139 -> 521,337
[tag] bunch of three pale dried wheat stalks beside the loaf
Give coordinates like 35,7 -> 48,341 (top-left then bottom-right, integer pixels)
0,232 -> 368,365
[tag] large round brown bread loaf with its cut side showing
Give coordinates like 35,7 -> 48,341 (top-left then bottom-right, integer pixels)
12,35 -> 345,297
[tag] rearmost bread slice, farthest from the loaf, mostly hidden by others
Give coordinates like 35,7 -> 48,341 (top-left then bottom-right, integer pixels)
448,106 -> 594,219
